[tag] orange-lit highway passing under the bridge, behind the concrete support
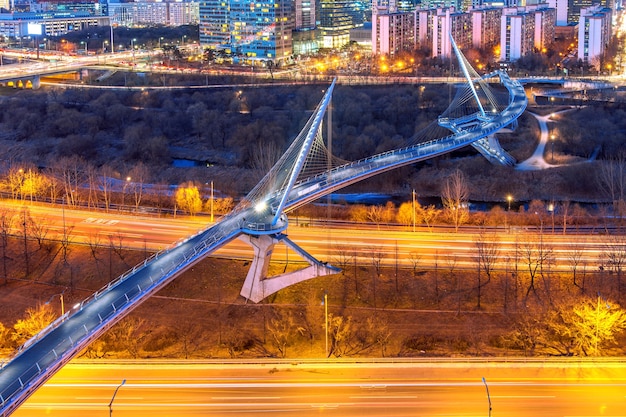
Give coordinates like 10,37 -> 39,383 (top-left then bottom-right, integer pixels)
0,200 -> 607,272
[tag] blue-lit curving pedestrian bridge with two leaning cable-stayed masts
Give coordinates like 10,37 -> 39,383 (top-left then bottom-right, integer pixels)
0,37 -> 527,417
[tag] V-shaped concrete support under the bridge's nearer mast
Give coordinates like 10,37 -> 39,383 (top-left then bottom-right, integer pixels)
239,233 -> 340,303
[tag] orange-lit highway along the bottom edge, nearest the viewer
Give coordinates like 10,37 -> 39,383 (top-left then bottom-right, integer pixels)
13,360 -> 626,417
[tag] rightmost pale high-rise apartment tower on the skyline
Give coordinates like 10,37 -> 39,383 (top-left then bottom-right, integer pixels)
578,5 -> 612,66
